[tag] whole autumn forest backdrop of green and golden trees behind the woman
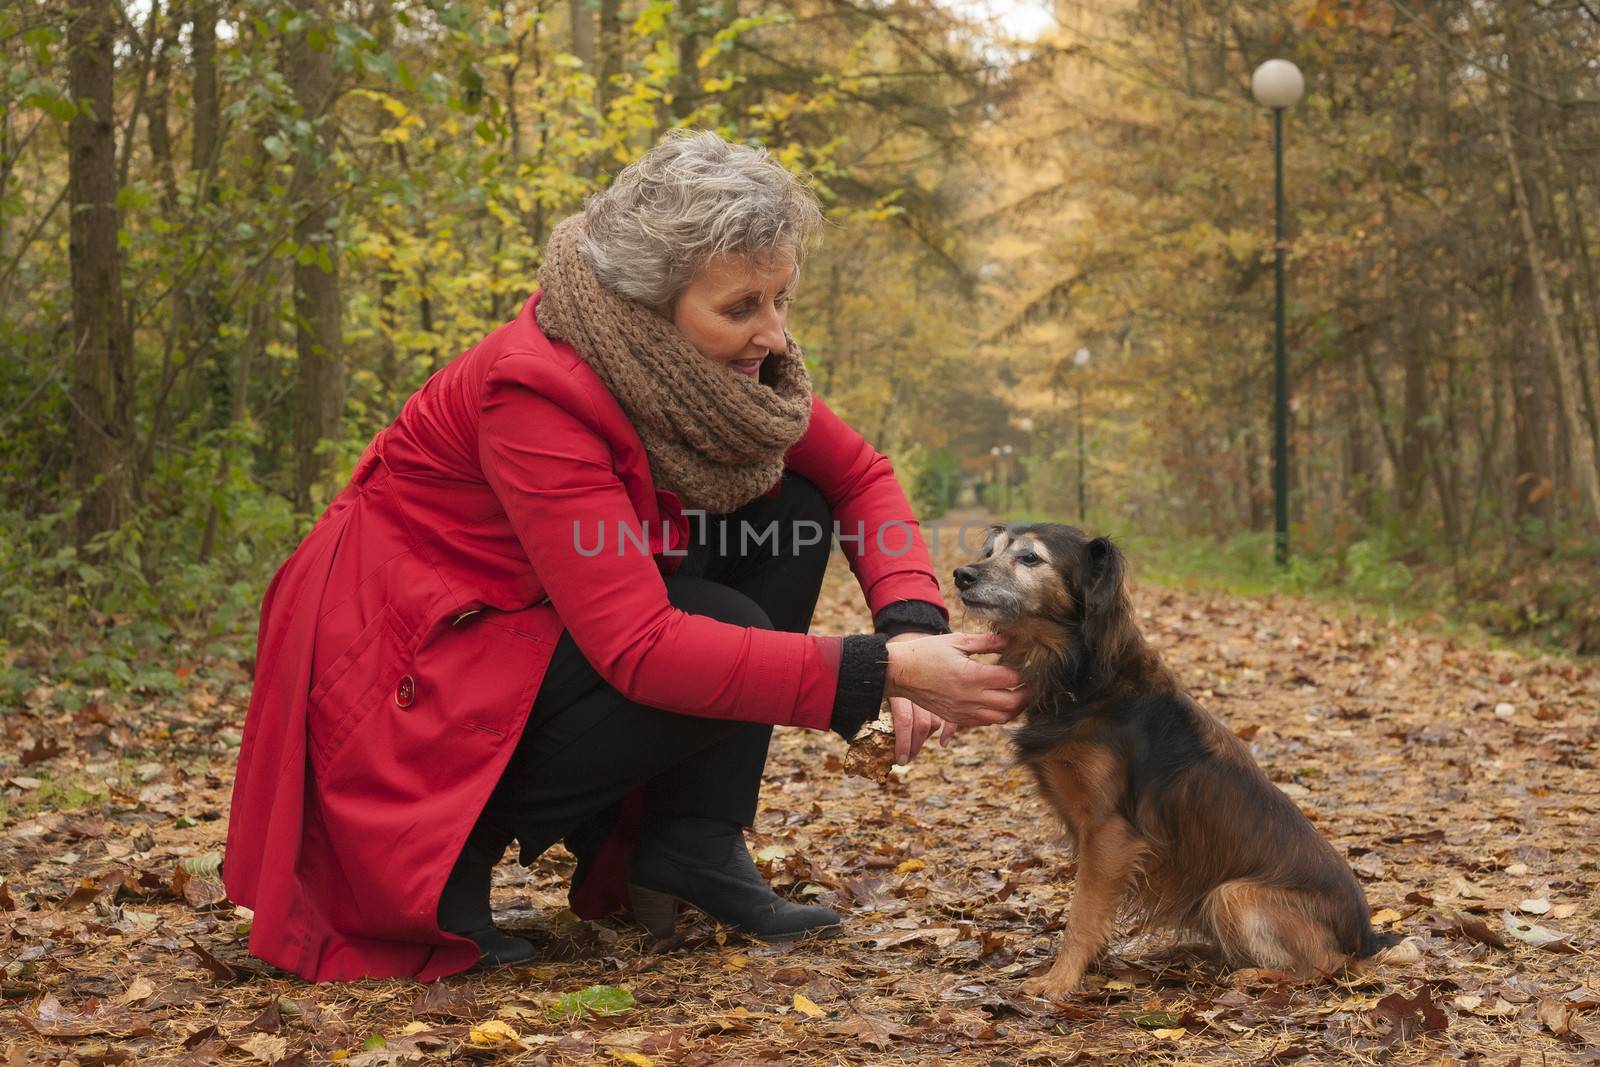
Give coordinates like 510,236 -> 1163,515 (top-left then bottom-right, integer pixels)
0,0 -> 1600,697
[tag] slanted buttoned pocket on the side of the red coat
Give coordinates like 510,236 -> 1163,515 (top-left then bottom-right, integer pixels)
307,605 -> 416,771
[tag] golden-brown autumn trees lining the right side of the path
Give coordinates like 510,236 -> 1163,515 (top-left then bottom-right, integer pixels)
974,0 -> 1600,651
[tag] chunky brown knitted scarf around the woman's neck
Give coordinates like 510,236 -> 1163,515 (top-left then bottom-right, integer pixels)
538,214 -> 811,512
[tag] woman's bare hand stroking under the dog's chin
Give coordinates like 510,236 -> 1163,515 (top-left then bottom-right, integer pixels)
883,633 -> 1032,726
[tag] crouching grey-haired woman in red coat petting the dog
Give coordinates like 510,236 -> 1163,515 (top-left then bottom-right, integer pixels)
224,133 -> 1024,981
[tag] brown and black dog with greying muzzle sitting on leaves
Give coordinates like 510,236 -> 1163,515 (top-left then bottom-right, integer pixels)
955,523 -> 1397,998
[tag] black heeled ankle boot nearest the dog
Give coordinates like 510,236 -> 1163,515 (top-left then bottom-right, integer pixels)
627,817 -> 840,939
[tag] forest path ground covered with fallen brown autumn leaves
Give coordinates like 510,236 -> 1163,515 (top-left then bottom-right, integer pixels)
0,531 -> 1600,1067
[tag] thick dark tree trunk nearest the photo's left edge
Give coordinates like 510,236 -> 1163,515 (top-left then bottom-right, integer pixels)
67,0 -> 134,545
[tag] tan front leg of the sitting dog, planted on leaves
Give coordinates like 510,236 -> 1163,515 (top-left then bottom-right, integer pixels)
1022,816 -> 1146,1000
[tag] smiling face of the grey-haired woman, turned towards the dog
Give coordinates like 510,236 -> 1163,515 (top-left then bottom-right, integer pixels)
672,253 -> 798,378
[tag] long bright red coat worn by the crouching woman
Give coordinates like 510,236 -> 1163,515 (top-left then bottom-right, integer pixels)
224,294 -> 941,981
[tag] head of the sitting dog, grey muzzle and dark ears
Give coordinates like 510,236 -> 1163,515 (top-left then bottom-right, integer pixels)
955,523 -> 1138,694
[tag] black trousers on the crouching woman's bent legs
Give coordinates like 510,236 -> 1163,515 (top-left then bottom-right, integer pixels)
467,475 -> 832,864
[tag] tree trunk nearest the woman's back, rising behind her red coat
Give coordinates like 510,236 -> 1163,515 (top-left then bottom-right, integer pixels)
285,0 -> 344,512
